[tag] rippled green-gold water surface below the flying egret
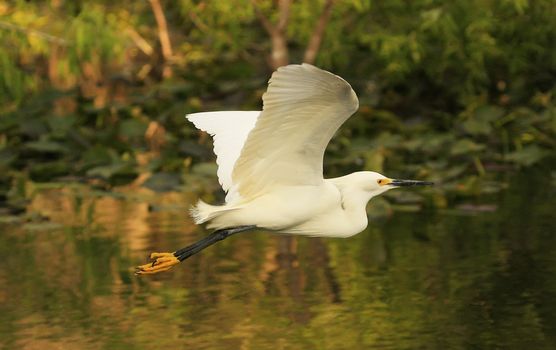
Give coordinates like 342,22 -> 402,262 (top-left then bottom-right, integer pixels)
0,170 -> 556,349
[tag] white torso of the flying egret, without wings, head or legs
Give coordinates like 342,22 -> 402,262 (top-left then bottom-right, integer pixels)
199,178 -> 368,237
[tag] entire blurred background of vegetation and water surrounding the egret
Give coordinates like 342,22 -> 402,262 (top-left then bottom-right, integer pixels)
0,0 -> 556,350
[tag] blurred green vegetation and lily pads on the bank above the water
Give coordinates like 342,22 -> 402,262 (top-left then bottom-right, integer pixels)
0,0 -> 556,211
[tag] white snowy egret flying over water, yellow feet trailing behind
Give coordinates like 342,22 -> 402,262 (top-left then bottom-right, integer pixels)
136,64 -> 432,274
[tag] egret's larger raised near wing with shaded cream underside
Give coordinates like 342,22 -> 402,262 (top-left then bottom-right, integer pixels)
232,64 -> 359,198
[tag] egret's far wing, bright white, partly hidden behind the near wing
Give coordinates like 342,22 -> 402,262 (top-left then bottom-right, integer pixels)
186,111 -> 261,198
